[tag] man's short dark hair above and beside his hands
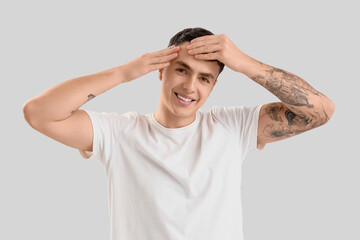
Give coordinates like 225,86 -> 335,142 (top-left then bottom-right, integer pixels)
168,27 -> 225,74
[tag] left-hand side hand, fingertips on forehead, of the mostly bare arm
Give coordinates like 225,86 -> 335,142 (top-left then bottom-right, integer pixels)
125,46 -> 180,81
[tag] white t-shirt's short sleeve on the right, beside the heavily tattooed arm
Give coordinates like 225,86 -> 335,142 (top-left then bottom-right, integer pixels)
211,105 -> 262,156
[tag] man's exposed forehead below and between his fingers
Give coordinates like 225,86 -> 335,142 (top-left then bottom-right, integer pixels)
171,42 -> 219,77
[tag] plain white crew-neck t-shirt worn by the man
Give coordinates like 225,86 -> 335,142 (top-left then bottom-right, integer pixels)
81,105 -> 261,240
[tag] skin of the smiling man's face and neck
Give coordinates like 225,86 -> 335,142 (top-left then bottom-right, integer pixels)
154,42 -> 220,128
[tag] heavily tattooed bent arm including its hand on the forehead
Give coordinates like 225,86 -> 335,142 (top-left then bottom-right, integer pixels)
188,34 -> 335,149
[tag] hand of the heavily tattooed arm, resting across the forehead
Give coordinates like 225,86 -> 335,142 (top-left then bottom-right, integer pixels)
188,34 -> 253,73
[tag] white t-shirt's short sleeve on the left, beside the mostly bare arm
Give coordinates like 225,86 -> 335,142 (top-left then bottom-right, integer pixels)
79,110 -> 137,167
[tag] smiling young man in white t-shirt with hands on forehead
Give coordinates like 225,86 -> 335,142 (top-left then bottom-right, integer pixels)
23,28 -> 334,240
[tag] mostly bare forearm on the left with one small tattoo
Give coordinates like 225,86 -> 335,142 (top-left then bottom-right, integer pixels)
23,62 -> 131,123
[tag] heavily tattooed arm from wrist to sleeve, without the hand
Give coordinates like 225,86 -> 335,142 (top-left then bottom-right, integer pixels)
245,62 -> 335,149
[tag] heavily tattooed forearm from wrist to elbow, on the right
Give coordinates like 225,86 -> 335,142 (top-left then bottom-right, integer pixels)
244,59 -> 334,124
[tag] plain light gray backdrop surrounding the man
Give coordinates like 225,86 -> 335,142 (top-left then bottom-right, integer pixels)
0,0 -> 360,240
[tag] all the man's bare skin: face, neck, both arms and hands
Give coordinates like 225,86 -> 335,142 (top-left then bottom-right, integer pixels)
23,34 -> 335,154
